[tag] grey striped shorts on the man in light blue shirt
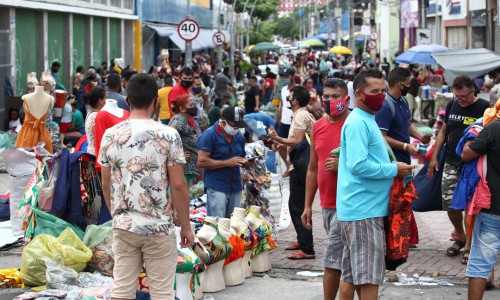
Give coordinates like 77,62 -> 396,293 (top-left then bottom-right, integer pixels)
340,218 -> 386,285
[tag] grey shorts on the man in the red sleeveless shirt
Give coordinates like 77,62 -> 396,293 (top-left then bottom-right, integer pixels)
321,208 -> 344,271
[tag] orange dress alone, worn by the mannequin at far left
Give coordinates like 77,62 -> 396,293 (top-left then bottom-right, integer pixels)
16,101 -> 53,153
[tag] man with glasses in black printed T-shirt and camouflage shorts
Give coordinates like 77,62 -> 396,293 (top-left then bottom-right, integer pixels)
427,75 -> 490,257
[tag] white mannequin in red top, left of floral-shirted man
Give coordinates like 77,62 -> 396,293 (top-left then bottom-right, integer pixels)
94,99 -> 130,172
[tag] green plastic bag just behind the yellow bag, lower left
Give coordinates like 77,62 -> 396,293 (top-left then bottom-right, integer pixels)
31,207 -> 83,240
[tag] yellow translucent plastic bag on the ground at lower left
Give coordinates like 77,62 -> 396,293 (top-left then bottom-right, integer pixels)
21,228 -> 92,286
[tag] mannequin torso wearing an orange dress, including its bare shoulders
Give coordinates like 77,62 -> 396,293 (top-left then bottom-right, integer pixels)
16,86 -> 54,153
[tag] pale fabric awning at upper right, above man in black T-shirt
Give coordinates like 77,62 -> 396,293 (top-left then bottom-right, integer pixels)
432,48 -> 500,83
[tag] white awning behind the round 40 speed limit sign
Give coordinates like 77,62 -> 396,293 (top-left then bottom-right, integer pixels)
147,24 -> 230,52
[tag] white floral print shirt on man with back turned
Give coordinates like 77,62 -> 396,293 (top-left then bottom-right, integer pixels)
99,119 -> 186,236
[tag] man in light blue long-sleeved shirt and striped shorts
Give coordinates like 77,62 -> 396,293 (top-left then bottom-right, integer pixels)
337,69 -> 413,299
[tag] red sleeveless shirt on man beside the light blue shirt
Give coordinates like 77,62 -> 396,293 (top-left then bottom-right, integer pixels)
312,116 -> 345,209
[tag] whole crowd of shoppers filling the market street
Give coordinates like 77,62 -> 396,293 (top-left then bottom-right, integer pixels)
6,48 -> 500,299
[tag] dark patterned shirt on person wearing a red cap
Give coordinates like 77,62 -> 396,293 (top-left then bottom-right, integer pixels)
168,114 -> 200,176
